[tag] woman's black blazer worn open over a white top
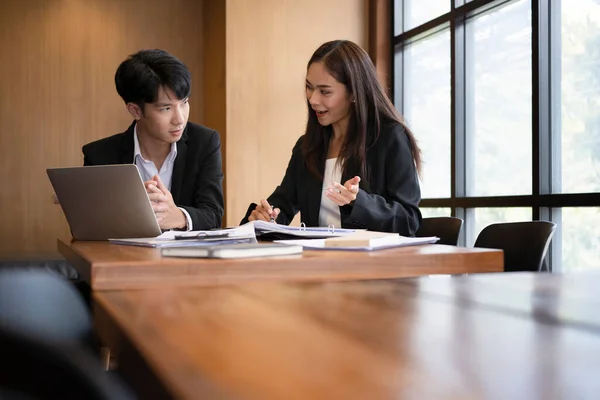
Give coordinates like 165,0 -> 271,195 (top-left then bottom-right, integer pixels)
242,123 -> 421,236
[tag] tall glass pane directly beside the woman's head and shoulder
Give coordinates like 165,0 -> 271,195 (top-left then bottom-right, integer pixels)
403,30 -> 451,198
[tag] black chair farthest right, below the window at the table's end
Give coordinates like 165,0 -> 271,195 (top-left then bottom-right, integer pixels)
474,221 -> 556,272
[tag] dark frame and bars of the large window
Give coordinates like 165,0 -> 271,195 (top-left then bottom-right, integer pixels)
390,0 -> 600,271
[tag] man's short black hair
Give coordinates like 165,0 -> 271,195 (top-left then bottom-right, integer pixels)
115,49 -> 192,111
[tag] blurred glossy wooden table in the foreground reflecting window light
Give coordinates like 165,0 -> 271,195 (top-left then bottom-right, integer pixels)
94,273 -> 600,400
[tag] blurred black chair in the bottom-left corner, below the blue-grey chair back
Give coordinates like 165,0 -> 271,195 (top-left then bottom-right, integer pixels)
0,323 -> 135,400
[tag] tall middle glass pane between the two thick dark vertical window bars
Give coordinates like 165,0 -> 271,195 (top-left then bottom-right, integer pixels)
466,0 -> 532,196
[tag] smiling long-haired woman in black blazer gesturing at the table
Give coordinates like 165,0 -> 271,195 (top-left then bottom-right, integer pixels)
242,40 -> 421,236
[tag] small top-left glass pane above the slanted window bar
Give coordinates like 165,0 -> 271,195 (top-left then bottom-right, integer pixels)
394,0 -> 451,35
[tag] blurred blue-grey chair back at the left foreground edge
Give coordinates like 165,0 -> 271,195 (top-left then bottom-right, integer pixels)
0,267 -> 99,351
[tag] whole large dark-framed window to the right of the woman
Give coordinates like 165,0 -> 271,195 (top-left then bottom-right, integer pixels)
393,0 -> 600,271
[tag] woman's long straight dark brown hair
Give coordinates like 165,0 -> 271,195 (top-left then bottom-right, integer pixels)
302,40 -> 421,180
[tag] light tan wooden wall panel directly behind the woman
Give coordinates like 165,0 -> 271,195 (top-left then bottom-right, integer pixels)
226,0 -> 368,225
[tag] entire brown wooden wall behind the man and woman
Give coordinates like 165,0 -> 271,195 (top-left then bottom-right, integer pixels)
0,0 -> 368,258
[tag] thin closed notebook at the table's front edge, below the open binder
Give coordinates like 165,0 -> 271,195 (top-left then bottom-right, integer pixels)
161,243 -> 302,258
